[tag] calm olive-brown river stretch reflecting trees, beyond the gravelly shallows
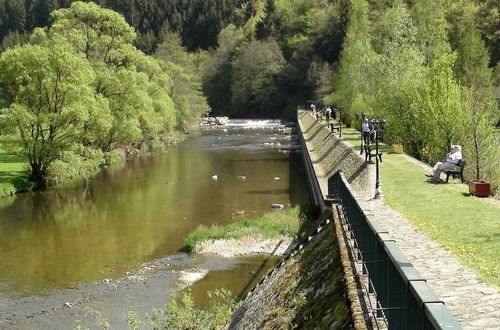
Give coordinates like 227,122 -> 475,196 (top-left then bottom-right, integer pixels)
0,121 -> 306,296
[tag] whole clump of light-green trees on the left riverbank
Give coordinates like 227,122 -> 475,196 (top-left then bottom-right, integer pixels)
0,2 -> 209,185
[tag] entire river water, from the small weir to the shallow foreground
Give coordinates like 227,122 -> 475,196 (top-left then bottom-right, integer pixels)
0,120 -> 308,328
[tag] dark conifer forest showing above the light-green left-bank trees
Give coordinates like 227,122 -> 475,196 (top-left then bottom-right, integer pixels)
0,0 -> 244,54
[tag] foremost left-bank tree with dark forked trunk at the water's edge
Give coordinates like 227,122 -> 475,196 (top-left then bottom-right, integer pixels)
0,40 -> 97,185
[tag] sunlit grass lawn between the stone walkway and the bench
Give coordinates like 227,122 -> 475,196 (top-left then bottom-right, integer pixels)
336,125 -> 500,287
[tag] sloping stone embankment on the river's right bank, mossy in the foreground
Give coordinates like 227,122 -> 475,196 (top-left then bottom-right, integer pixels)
230,111 -> 373,329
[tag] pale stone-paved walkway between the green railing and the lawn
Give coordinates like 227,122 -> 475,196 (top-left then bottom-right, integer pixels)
300,114 -> 500,329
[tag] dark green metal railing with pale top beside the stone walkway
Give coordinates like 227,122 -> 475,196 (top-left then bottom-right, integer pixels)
328,171 -> 462,329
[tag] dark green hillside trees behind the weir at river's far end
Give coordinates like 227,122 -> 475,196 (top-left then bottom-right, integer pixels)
203,0 -> 349,118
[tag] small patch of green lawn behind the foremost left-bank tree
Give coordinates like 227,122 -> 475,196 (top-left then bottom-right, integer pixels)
0,149 -> 33,197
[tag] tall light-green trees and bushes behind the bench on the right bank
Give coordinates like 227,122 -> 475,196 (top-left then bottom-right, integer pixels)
330,0 -> 500,185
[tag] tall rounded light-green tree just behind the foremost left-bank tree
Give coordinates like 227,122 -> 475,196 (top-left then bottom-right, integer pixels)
39,2 -> 176,152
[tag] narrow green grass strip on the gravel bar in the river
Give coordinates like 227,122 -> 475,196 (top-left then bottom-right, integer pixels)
184,206 -> 313,251
